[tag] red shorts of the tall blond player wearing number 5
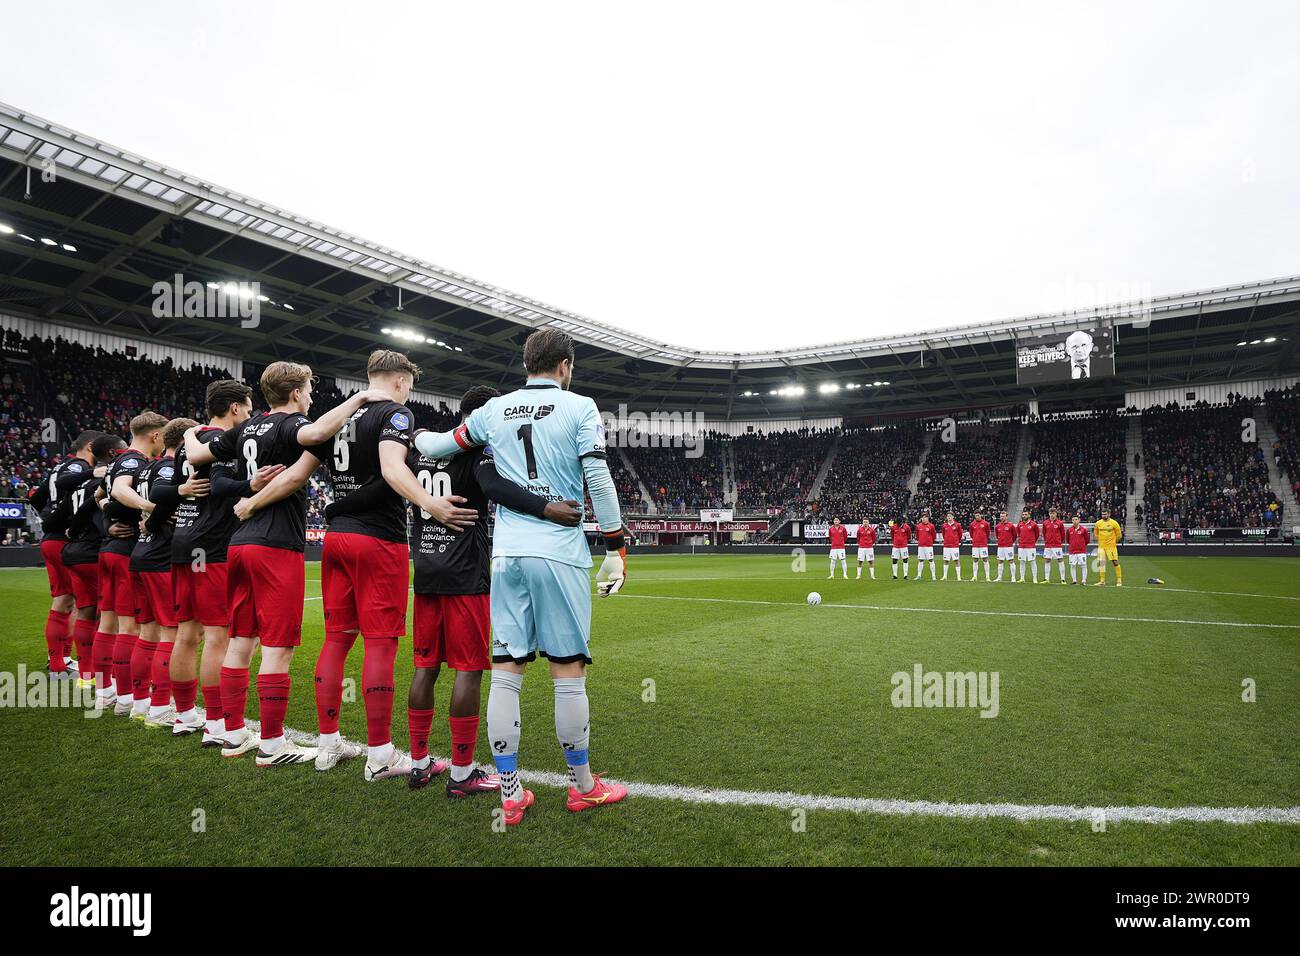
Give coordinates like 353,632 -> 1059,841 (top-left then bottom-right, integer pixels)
321,531 -> 411,637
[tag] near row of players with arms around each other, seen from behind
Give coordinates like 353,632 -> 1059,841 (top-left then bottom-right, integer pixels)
33,333 -> 627,823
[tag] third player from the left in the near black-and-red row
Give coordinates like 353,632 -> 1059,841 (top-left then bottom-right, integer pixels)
99,411 -> 166,719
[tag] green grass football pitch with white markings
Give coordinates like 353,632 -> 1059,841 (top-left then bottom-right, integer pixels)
0,554 -> 1300,866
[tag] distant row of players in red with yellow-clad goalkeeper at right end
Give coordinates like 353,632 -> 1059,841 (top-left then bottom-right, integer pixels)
827,509 -> 1125,587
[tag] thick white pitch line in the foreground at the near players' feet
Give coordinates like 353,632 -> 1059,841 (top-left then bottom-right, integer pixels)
213,709 -> 1300,826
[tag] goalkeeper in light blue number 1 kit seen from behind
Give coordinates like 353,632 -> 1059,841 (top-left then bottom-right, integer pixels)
415,329 -> 628,826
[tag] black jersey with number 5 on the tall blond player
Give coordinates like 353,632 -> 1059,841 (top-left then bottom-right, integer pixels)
319,402 -> 410,541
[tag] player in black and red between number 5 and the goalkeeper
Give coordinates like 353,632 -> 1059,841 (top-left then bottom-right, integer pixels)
325,385 -> 582,797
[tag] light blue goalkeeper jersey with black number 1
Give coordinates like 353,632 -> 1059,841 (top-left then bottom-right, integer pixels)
462,378 -> 605,567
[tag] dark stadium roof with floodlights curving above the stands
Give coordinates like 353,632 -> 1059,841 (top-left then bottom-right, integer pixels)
0,104 -> 1300,420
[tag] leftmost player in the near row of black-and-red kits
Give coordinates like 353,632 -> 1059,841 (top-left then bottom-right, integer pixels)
31,432 -> 100,683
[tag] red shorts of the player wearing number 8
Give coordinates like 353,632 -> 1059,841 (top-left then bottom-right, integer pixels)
226,545 -> 307,648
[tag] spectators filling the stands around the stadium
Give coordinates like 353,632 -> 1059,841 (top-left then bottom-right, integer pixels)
0,329 -> 1300,541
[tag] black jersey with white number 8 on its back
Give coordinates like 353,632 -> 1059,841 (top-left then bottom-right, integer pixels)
209,411 -> 329,561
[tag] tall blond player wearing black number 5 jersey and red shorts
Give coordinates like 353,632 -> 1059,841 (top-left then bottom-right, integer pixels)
244,349 -> 477,780
